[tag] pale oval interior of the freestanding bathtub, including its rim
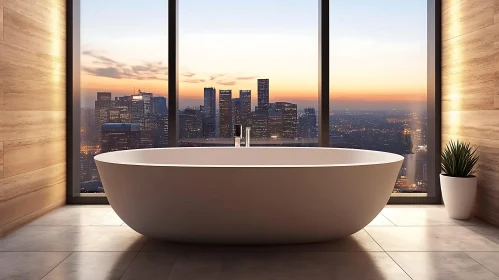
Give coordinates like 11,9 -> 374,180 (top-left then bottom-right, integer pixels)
95,147 -> 403,167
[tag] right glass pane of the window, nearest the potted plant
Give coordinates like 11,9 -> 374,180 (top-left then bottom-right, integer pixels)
329,0 -> 428,195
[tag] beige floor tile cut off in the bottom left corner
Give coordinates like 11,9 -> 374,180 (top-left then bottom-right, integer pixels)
0,252 -> 71,280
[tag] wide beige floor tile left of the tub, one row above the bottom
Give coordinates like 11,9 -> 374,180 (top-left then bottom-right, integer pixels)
0,226 -> 145,252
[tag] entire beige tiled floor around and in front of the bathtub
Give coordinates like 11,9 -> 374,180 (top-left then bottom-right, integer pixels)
0,206 -> 499,280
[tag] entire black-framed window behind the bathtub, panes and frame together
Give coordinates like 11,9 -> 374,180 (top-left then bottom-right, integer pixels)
68,0 -> 440,202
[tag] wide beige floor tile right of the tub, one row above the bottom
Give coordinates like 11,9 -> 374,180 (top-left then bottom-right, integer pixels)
366,226 -> 499,251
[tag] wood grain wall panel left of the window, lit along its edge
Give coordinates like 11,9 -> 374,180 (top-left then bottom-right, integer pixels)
0,0 -> 66,237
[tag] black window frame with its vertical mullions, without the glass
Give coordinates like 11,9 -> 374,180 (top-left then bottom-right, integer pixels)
66,0 -> 442,204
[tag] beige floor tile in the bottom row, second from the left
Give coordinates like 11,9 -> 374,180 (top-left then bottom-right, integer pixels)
43,252 -> 137,280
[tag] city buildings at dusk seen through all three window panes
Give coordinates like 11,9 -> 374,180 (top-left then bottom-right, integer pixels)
80,79 -> 427,193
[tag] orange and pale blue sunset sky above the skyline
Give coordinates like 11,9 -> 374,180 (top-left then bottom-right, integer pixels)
81,0 -> 426,108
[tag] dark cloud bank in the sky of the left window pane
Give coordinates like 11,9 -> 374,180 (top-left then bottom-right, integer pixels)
82,50 -> 168,81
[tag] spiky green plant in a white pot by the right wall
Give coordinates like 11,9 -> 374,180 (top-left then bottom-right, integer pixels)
440,140 -> 479,220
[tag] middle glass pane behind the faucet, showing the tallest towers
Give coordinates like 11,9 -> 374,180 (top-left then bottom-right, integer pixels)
179,0 -> 318,147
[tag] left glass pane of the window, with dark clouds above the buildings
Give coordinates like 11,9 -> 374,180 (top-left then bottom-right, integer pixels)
80,0 -> 168,193
